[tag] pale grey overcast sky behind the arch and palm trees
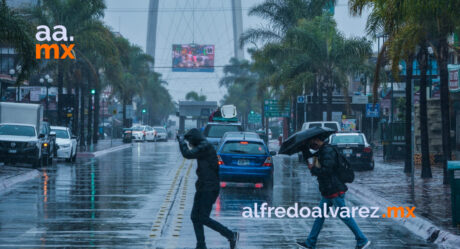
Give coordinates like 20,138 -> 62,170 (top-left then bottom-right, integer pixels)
104,0 -> 367,101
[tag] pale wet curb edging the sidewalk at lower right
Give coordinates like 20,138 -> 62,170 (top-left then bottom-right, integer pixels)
348,184 -> 460,248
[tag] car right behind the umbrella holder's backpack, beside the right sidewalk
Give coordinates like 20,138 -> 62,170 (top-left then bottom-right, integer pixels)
329,132 -> 375,170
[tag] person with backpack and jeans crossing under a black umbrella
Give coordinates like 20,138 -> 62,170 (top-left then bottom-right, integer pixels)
280,127 -> 371,249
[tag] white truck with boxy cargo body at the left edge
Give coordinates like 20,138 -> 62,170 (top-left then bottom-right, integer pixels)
0,102 -> 57,167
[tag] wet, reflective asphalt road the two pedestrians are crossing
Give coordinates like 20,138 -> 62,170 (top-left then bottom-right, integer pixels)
0,142 -> 434,249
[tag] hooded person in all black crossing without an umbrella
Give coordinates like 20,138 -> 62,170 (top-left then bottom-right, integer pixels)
177,129 -> 239,249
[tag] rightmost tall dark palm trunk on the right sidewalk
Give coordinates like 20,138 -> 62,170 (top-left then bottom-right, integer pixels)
438,37 -> 452,184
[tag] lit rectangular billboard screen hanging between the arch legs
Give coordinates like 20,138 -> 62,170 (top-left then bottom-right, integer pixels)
172,44 -> 214,72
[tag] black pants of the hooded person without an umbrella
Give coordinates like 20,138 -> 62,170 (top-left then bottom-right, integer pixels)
191,191 -> 233,247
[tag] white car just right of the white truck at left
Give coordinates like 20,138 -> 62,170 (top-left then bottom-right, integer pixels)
51,126 -> 77,162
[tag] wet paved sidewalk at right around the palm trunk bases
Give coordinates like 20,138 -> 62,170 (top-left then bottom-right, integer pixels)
351,148 -> 460,241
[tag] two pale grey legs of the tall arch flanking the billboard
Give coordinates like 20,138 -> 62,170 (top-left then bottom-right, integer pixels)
147,0 -> 244,60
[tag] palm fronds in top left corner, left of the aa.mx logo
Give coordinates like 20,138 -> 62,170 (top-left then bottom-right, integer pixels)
0,0 -> 37,92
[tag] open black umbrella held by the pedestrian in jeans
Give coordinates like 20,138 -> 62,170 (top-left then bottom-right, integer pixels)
279,127 -> 335,155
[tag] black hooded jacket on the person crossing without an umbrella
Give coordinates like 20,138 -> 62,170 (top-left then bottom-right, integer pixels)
179,129 -> 220,191
